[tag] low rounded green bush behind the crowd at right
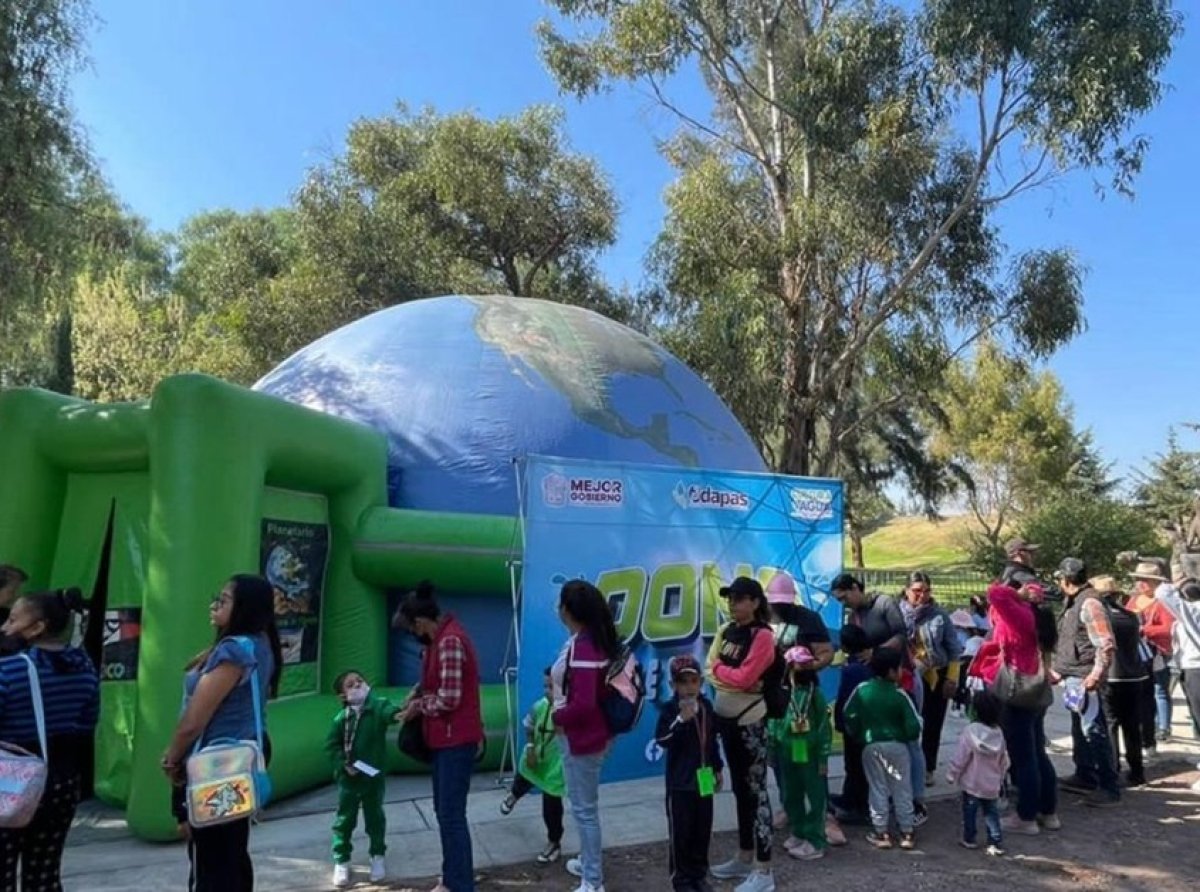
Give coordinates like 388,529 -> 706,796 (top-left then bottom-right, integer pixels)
1018,493 -> 1163,575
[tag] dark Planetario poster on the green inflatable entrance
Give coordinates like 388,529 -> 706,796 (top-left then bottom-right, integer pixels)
262,517 -> 329,666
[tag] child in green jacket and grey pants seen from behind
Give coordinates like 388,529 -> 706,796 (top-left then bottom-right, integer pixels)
844,647 -> 920,849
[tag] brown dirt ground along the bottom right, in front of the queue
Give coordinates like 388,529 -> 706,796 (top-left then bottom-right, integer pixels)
404,762 -> 1200,892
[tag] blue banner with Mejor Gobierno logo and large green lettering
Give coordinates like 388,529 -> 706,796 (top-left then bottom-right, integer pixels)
517,456 -> 842,780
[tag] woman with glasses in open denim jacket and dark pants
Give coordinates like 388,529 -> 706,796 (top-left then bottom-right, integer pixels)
900,570 -> 962,784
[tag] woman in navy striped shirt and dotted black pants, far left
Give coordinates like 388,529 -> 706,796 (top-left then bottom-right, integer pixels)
0,588 -> 100,892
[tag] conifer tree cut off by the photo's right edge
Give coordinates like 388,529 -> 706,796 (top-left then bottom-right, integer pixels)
1133,430 -> 1200,557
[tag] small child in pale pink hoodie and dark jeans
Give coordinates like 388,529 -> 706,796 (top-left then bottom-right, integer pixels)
946,690 -> 1008,855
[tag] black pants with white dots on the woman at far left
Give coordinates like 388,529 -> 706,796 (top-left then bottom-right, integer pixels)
0,773 -> 79,892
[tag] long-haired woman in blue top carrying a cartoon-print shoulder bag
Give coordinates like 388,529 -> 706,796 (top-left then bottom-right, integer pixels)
162,575 -> 283,892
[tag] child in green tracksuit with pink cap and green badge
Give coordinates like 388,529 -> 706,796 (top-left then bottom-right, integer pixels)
769,646 -> 833,861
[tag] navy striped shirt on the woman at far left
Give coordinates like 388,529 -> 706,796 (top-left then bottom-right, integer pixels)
0,647 -> 100,752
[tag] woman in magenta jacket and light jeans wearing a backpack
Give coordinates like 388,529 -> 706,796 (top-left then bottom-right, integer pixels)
550,579 -> 620,892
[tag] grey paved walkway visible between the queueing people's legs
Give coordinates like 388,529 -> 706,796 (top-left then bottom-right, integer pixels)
62,700 -> 1200,892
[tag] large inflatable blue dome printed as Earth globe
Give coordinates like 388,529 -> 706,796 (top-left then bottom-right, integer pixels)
254,297 -> 766,515
